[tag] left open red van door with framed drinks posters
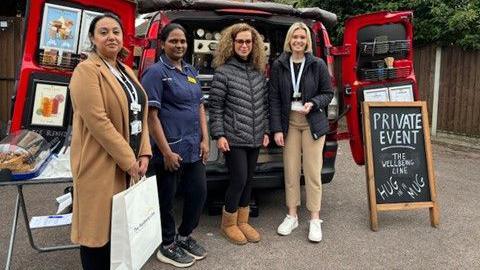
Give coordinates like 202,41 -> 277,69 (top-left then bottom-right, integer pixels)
10,0 -> 136,148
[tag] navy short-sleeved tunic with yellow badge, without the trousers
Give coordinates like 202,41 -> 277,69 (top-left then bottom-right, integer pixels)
142,55 -> 202,163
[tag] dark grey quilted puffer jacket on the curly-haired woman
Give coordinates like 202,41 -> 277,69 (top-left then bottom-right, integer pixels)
208,57 -> 269,147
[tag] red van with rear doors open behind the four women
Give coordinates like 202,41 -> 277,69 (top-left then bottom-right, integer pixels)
11,0 -> 418,194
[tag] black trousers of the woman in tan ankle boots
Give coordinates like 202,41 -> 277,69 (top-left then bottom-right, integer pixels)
225,147 -> 260,213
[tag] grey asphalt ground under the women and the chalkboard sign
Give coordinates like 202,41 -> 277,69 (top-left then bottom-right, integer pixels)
0,142 -> 480,269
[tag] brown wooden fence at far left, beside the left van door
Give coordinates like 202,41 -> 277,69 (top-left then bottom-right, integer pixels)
0,17 -> 23,129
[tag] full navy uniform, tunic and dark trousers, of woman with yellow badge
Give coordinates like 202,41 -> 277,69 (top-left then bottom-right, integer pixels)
142,55 -> 206,245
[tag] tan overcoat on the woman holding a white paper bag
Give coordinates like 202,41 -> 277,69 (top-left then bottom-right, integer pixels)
70,53 -> 152,247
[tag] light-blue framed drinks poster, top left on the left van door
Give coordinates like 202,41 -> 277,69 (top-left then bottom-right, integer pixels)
40,3 -> 81,53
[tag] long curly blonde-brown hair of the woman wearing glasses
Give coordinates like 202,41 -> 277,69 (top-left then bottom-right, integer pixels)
213,23 -> 267,73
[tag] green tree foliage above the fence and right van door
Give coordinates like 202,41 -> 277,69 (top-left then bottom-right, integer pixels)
277,0 -> 480,50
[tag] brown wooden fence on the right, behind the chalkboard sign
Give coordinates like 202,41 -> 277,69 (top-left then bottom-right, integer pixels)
414,46 -> 480,136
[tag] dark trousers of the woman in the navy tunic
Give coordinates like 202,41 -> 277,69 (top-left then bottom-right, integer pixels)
156,160 -> 207,246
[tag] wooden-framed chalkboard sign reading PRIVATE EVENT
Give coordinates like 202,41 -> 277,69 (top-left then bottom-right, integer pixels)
363,101 -> 439,231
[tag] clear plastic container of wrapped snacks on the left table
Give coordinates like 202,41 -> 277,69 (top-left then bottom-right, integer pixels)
0,130 -> 52,180
